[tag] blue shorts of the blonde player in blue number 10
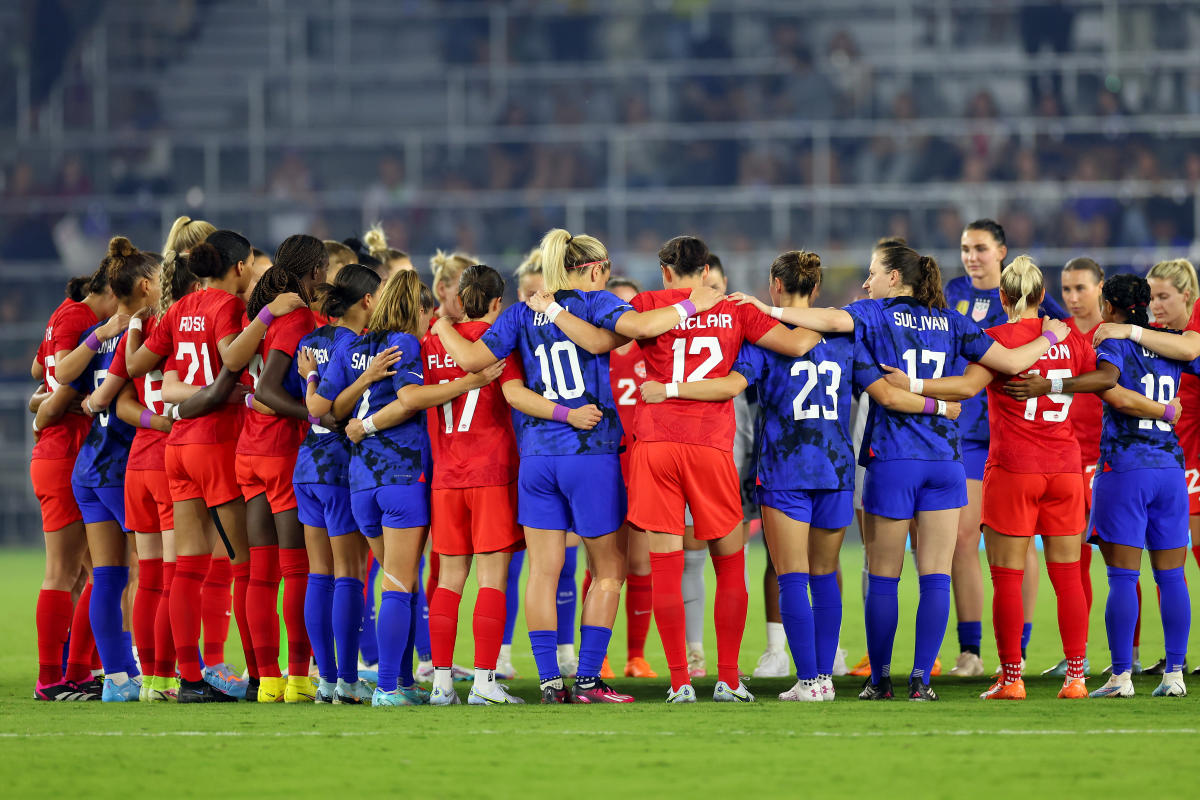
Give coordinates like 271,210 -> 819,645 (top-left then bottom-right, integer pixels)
517,453 -> 626,539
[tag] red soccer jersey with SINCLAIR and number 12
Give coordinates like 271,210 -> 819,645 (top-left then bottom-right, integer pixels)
631,289 -> 779,452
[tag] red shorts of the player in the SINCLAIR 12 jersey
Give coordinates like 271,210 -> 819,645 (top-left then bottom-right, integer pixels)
629,441 -> 743,541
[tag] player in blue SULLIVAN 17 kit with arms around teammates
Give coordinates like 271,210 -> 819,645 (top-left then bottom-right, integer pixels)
753,246 -> 1069,700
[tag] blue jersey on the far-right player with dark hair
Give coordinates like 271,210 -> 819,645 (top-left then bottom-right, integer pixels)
1096,340 -> 1198,473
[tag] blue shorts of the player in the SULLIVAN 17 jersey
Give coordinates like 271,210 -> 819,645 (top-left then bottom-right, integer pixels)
863,458 -> 967,519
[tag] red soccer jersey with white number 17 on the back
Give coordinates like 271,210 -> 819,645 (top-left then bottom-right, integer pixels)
421,321 -> 524,489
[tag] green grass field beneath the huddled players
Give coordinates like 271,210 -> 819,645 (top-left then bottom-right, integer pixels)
0,545 -> 1200,799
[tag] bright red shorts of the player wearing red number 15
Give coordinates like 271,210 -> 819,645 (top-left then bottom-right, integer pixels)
979,464 -> 1087,536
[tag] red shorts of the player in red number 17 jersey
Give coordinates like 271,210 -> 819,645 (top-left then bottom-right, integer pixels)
430,481 -> 524,555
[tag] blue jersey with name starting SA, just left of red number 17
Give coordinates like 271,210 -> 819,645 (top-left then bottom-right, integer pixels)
317,331 -> 430,492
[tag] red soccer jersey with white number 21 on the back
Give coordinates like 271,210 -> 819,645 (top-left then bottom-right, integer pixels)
145,289 -> 245,445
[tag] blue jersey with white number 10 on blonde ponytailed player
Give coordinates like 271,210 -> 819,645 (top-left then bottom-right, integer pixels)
480,289 -> 634,456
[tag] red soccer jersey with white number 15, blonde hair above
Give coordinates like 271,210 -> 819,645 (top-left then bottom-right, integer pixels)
988,319 -> 1096,475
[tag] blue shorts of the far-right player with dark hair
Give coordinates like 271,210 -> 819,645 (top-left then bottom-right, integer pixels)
1094,469 -> 1190,551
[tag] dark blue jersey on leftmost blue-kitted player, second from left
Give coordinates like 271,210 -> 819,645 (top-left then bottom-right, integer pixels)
71,323 -> 136,488
